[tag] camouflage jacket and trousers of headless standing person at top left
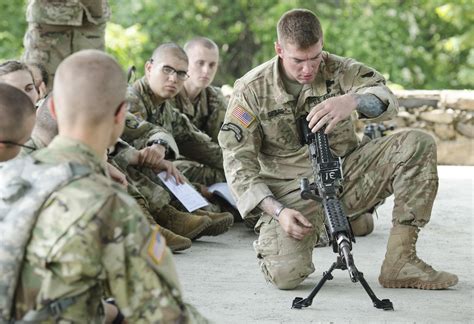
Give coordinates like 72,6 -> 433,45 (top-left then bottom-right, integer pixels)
23,0 -> 110,89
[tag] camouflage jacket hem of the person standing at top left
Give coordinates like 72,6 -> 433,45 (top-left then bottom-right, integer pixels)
26,0 -> 110,26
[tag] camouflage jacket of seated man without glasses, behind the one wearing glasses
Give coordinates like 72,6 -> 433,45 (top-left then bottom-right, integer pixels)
172,86 -> 227,143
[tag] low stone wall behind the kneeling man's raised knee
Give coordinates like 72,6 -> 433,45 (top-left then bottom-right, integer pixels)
359,90 -> 474,165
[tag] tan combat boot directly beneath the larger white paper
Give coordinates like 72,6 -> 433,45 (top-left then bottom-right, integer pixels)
156,205 -> 212,240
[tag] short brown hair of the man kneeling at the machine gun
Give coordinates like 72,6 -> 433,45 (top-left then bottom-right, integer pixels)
277,9 -> 323,49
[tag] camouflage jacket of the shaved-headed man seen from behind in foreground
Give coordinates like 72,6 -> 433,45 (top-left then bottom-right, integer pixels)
15,137 -> 205,323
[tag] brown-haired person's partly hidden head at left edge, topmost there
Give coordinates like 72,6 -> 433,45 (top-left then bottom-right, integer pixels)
0,60 -> 38,104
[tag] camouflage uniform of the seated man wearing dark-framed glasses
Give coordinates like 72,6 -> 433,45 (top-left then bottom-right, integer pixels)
122,77 -> 225,185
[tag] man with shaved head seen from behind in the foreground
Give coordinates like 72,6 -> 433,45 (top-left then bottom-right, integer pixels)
15,50 -> 206,323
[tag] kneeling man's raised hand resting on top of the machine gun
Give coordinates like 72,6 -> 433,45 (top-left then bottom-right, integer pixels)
306,94 -> 357,134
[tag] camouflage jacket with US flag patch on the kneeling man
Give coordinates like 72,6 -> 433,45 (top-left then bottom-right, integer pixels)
219,52 -> 398,217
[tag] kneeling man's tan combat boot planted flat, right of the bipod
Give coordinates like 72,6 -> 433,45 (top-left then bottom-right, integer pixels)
379,225 -> 458,289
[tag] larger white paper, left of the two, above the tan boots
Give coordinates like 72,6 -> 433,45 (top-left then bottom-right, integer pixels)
158,171 -> 209,213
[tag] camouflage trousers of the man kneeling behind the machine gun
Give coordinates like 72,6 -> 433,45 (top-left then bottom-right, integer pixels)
254,130 -> 438,289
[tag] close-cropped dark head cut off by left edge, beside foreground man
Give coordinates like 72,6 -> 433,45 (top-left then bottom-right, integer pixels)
0,82 -> 35,165
